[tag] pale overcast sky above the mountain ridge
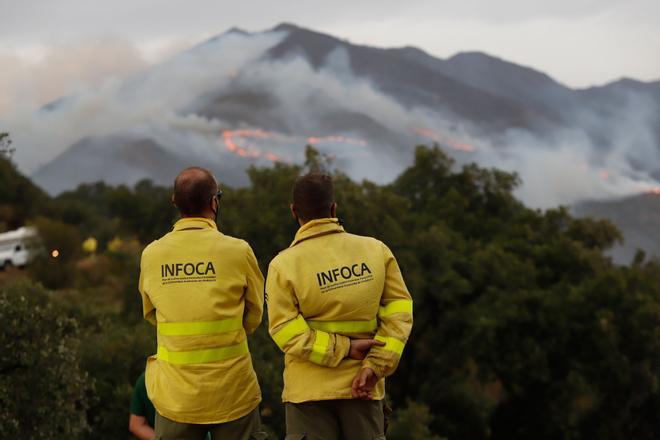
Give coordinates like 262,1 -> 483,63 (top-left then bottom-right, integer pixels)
0,0 -> 660,117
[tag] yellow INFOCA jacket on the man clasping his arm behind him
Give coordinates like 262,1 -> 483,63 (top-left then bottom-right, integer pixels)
266,218 -> 412,403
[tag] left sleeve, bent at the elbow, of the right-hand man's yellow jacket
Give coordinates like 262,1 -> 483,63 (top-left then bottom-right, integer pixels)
266,264 -> 351,367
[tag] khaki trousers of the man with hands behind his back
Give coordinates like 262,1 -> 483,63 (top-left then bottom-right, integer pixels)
285,399 -> 385,440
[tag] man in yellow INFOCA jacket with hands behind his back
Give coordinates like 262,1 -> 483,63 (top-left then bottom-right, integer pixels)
266,174 -> 412,440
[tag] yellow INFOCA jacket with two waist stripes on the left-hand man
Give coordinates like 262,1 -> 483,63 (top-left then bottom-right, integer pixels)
139,218 -> 264,423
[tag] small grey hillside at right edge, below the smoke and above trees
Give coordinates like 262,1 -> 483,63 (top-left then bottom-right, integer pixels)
574,194 -> 660,264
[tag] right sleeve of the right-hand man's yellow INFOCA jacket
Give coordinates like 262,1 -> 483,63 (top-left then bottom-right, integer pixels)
362,244 -> 413,378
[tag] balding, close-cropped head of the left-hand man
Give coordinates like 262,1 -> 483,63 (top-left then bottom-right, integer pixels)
174,167 -> 218,217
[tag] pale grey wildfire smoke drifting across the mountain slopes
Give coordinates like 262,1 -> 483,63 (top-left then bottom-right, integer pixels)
2,27 -> 660,207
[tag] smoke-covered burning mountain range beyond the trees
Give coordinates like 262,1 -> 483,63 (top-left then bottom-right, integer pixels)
2,24 -> 660,207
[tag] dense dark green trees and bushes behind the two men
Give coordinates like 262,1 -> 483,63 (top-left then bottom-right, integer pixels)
0,147 -> 660,440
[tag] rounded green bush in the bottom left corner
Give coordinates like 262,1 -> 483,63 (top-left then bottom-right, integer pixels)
0,283 -> 88,439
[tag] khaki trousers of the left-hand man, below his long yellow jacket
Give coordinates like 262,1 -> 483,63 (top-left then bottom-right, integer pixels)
156,406 -> 268,440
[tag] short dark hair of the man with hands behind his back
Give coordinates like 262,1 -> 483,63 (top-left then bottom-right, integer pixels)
293,173 -> 335,221
